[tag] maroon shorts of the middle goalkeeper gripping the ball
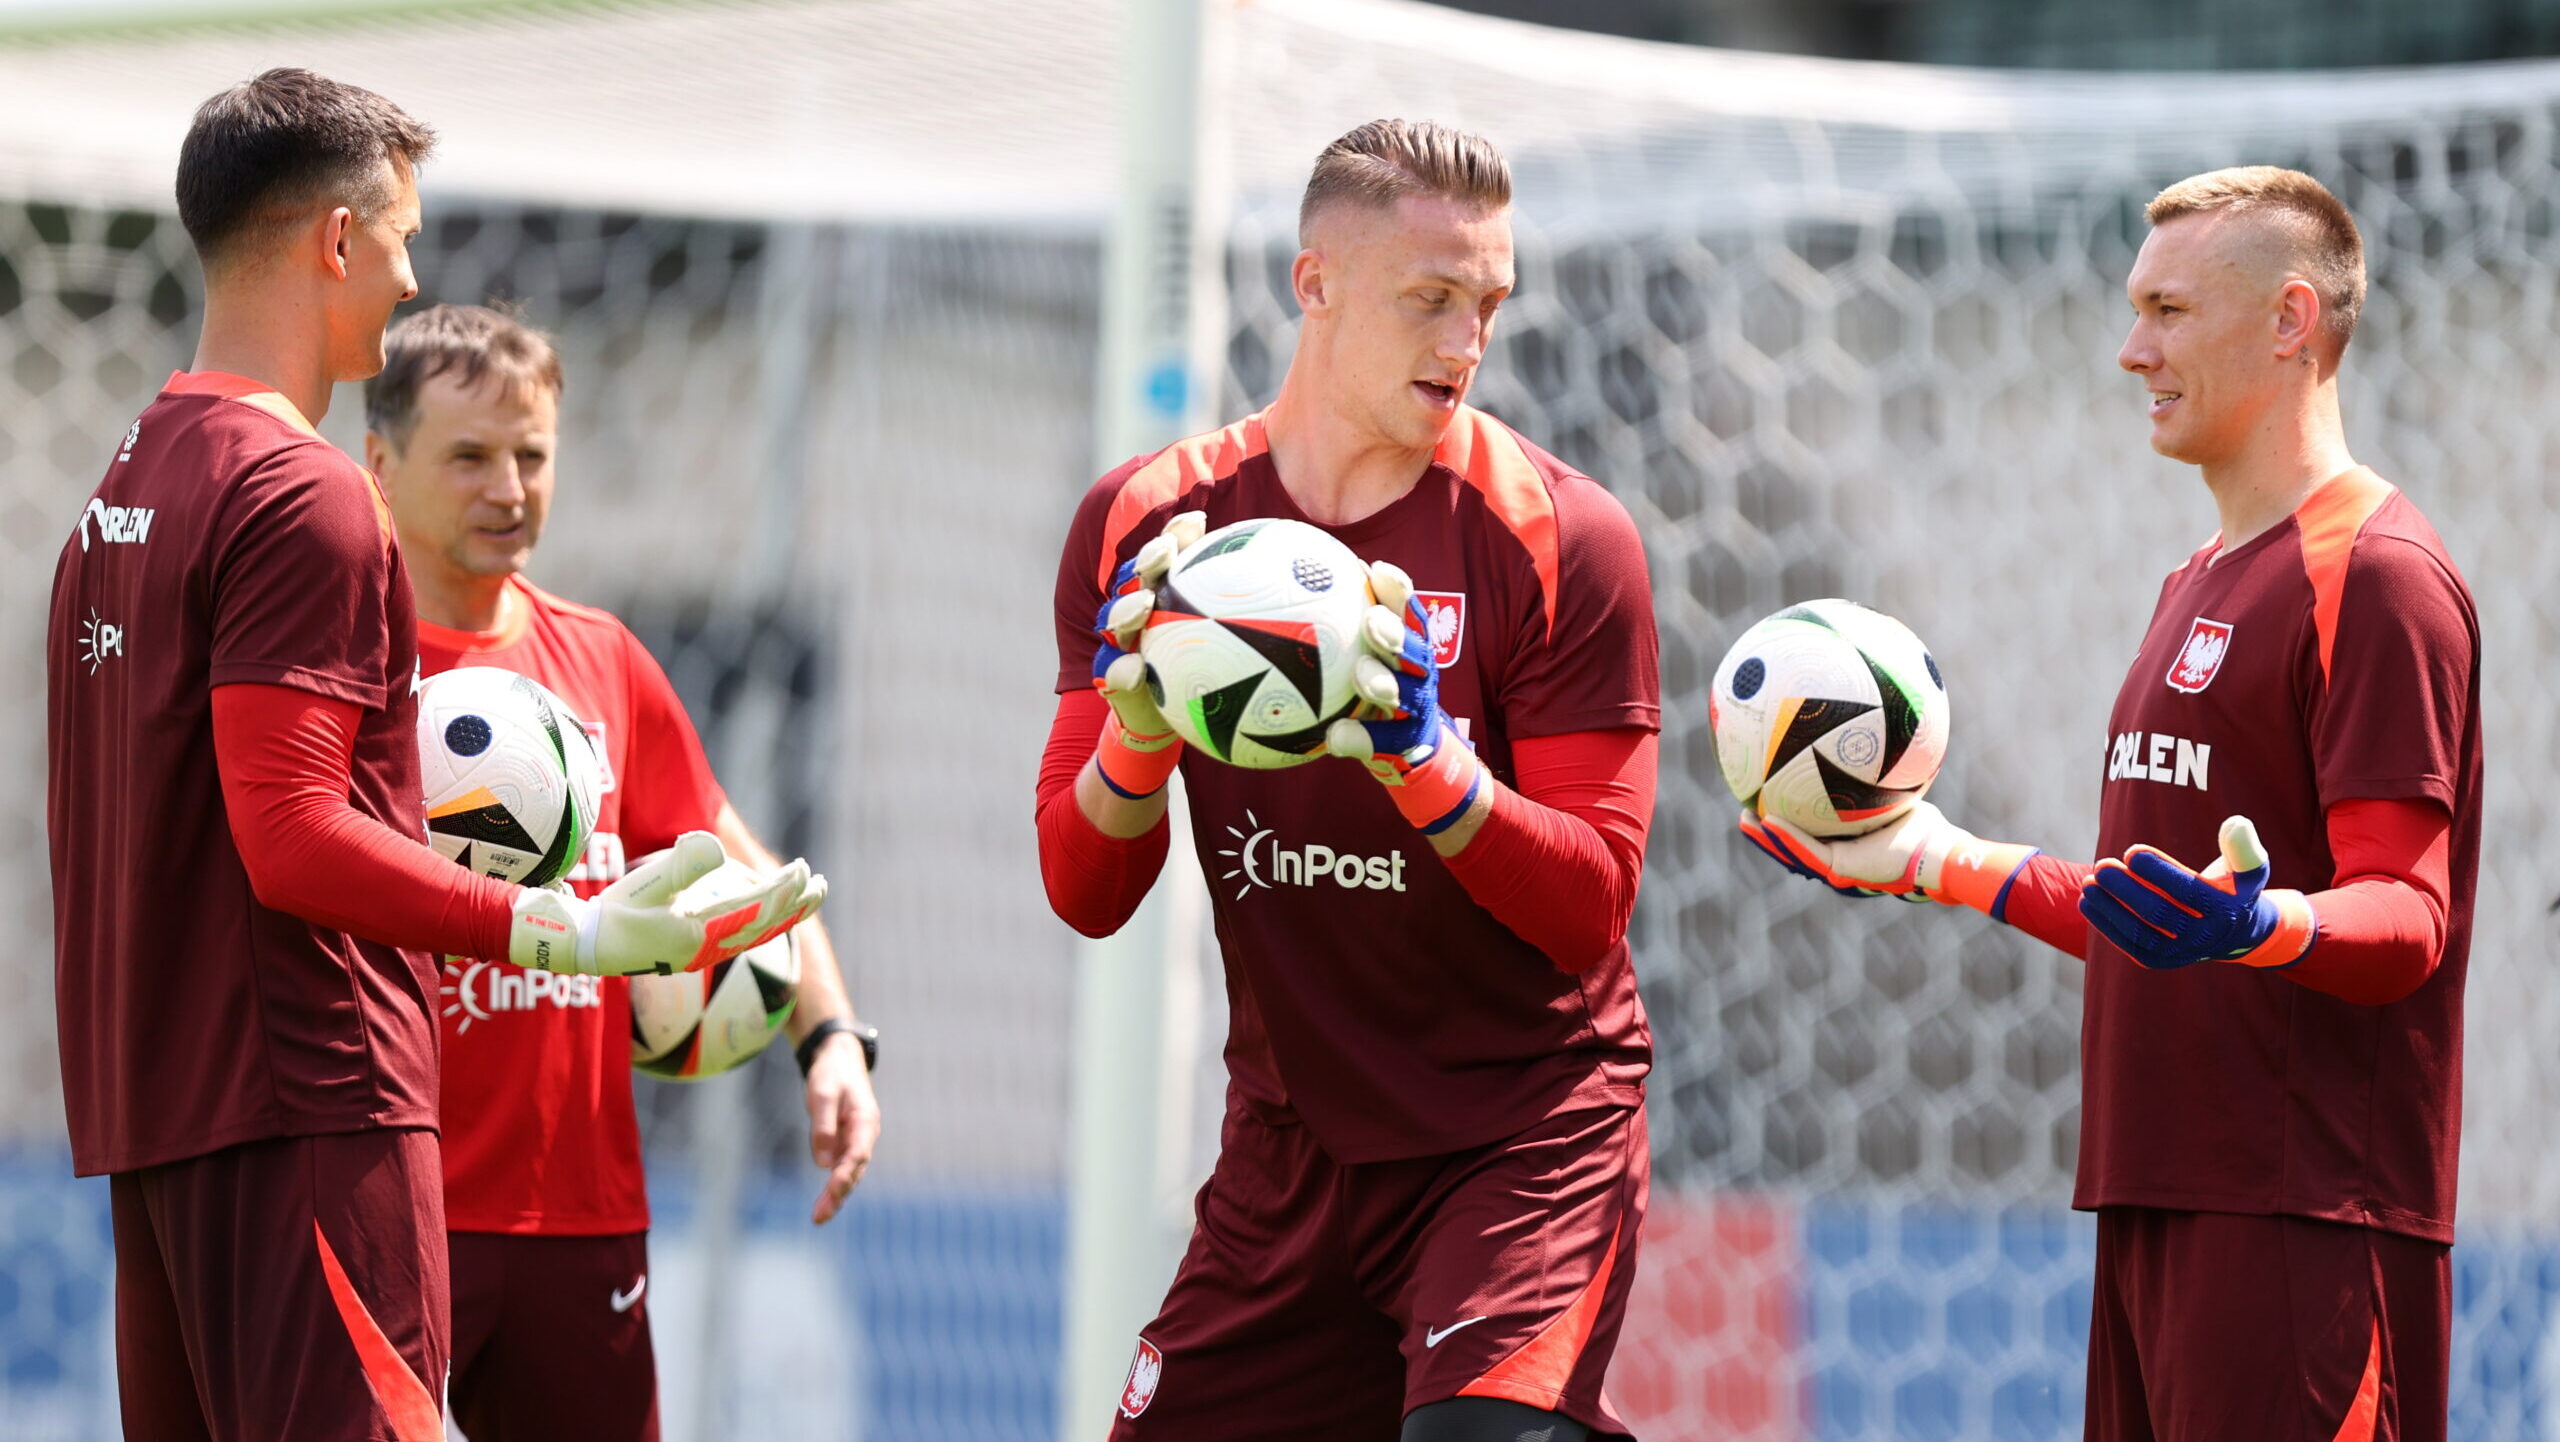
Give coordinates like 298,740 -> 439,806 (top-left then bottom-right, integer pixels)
1111,1106 -> 1651,1442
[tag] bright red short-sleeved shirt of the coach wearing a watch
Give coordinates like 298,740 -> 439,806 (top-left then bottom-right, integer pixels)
417,576 -> 724,1237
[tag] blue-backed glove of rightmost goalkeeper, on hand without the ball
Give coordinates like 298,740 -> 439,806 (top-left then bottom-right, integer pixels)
2081,817 -> 2319,971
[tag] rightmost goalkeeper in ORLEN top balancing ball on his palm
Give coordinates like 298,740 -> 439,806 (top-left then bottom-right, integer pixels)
1743,166 -> 2481,1442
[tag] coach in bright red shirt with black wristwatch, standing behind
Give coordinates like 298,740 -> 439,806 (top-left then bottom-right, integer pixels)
364,305 -> 881,1442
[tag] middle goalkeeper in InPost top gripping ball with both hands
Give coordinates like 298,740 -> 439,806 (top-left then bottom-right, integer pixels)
1039,120 -> 1659,1442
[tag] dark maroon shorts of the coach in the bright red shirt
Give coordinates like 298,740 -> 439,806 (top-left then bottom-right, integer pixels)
451,1232 -> 658,1442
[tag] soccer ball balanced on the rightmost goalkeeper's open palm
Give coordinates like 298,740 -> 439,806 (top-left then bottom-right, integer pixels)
1708,602 -> 1948,838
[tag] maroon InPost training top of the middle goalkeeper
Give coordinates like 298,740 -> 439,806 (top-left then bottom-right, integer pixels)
1057,407 -> 1661,1163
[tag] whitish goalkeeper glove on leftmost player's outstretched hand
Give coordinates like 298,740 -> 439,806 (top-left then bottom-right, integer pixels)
507,832 -> 827,976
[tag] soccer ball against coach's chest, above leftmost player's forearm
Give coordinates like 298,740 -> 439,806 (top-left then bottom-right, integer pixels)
417,666 -> 604,886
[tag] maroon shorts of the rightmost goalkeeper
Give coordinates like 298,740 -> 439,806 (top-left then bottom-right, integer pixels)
2086,1206 -> 2452,1442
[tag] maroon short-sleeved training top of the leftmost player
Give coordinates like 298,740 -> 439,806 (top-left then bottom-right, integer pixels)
46,371 -> 435,1176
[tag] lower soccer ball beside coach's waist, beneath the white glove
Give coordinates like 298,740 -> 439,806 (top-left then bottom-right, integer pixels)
630,861 -> 799,1081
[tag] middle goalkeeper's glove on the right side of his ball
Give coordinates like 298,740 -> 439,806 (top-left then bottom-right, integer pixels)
1324,561 -> 1485,835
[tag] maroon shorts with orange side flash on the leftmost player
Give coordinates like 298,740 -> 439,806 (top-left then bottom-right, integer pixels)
108,1130 -> 445,1442
